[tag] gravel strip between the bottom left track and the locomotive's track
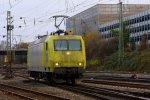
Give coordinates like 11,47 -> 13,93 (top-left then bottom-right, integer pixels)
0,75 -> 95,100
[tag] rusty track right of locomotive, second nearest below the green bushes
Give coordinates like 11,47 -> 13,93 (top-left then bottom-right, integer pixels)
81,80 -> 150,90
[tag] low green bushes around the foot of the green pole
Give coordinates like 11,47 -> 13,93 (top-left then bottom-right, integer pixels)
103,50 -> 150,72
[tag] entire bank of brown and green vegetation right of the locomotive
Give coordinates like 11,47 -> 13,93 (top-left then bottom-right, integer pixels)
84,32 -> 150,72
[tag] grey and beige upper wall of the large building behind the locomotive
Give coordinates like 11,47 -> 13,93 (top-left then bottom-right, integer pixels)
66,4 -> 149,34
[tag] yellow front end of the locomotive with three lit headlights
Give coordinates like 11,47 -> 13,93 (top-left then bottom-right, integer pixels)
53,36 -> 86,79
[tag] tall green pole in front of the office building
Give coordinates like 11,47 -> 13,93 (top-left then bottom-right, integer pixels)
119,0 -> 124,65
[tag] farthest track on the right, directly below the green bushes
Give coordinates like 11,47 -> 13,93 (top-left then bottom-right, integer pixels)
83,72 -> 150,83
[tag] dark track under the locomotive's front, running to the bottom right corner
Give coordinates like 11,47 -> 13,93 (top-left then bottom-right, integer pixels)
57,85 -> 148,100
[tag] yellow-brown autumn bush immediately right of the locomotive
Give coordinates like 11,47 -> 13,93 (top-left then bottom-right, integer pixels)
84,32 -> 118,67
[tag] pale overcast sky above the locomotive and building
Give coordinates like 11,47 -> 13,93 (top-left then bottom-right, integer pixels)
0,0 -> 150,42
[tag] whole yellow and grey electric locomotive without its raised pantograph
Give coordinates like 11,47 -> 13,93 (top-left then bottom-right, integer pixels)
28,32 -> 86,84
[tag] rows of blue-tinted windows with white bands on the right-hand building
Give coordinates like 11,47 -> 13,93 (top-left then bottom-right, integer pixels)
99,11 -> 150,42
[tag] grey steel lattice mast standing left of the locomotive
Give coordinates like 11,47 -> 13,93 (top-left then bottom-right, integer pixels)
5,11 -> 14,78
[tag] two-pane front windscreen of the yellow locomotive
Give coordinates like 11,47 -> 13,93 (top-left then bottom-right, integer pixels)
54,40 -> 82,51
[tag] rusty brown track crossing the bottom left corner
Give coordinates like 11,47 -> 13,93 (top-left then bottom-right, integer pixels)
0,83 -> 68,100
